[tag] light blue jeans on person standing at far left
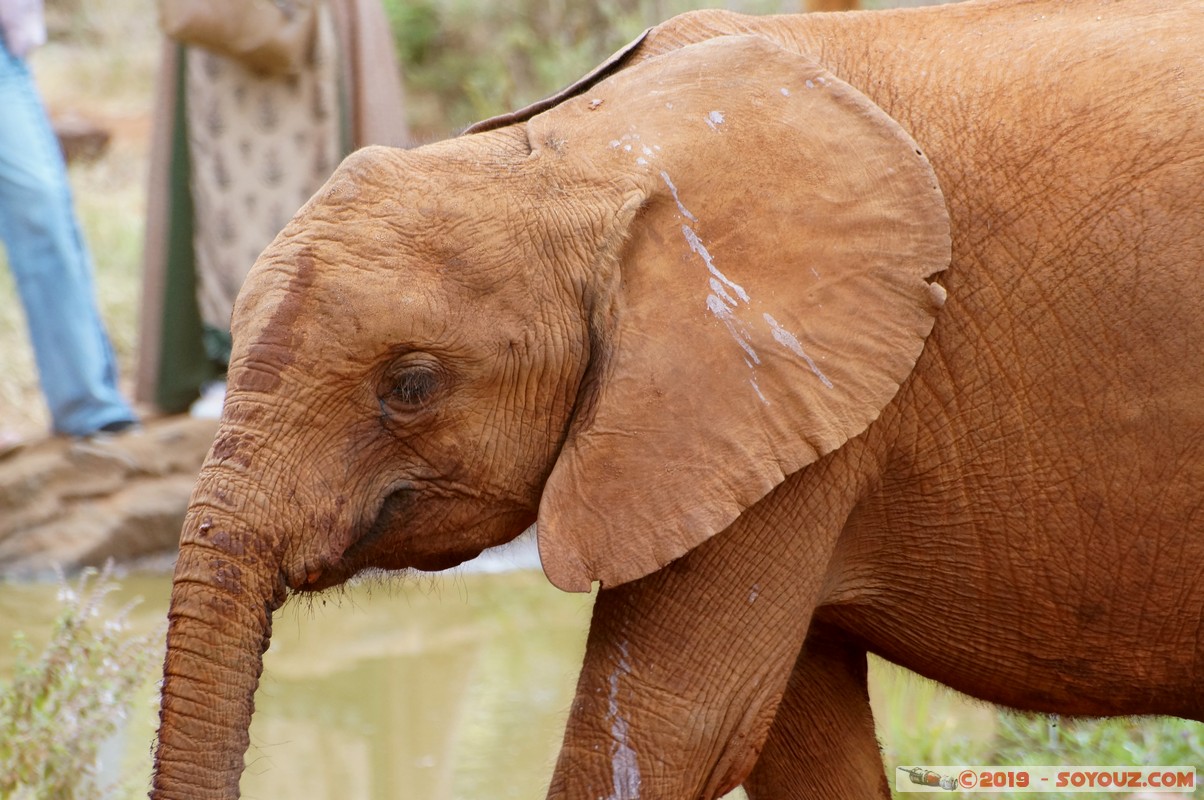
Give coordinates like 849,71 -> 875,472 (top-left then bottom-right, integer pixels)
0,39 -> 136,436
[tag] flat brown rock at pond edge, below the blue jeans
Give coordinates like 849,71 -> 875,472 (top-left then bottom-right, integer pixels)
0,417 -> 218,577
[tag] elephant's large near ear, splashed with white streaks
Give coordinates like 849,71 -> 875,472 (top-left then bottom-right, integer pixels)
527,36 -> 950,592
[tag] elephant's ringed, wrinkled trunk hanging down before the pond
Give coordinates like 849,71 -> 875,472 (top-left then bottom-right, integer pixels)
151,472 -> 285,800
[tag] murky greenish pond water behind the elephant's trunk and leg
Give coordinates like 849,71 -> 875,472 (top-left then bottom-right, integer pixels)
0,561 -> 592,800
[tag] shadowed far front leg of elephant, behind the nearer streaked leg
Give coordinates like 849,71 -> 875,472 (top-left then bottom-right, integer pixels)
744,628 -> 891,800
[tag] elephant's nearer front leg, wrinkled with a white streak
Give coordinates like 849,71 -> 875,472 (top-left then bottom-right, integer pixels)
548,457 -> 856,800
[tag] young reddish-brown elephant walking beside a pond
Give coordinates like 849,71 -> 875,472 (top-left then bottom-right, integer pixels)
151,0 -> 1204,800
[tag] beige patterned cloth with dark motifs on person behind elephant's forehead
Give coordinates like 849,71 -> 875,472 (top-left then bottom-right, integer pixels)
185,5 -> 344,361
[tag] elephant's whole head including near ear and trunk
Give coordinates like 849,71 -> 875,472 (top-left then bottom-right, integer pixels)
153,37 -> 949,798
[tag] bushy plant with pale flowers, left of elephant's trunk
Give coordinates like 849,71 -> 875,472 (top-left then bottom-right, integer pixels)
0,566 -> 162,800
